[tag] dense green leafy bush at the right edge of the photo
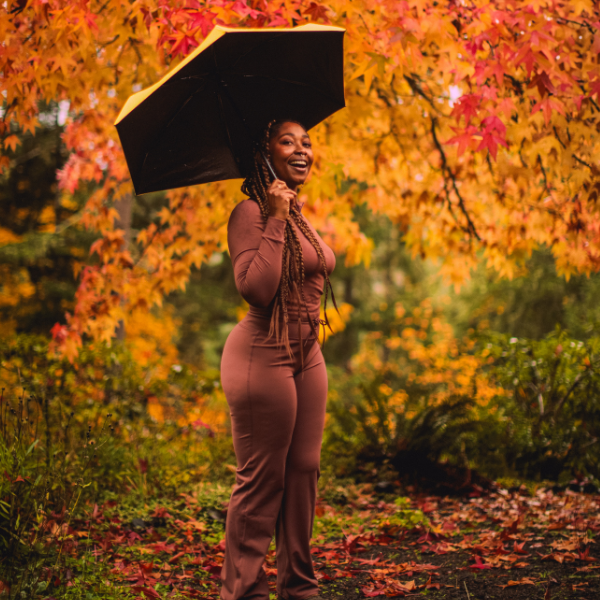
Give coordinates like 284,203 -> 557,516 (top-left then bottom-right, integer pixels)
486,330 -> 600,481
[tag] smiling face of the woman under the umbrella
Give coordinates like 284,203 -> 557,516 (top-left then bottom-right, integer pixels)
269,122 -> 313,191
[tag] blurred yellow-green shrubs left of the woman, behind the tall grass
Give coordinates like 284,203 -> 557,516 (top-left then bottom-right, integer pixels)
0,336 -> 232,504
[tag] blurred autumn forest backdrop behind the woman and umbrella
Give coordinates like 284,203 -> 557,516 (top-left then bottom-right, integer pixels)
0,0 -> 600,596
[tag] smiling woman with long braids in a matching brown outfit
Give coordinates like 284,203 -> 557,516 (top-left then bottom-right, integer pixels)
221,120 -> 335,600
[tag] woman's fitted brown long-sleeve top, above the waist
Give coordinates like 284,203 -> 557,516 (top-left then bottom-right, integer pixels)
227,199 -> 335,322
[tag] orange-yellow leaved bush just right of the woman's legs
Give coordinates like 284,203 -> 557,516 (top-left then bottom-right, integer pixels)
325,299 -> 504,482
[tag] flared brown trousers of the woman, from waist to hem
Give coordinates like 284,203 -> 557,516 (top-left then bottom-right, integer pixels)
221,322 -> 327,600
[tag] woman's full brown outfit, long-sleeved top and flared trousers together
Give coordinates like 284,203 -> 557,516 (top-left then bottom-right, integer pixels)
221,200 -> 335,600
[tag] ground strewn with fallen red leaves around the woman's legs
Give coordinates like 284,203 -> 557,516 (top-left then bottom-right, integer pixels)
48,484 -> 600,600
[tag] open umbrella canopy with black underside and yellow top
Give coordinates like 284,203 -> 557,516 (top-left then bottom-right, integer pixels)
115,25 -> 345,194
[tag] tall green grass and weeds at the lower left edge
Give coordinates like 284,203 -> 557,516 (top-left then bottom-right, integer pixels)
0,390 -> 112,598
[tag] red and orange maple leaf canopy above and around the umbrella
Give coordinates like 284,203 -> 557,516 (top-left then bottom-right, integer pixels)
0,0 -> 600,356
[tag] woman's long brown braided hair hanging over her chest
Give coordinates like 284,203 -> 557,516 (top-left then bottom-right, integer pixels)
242,119 -> 337,362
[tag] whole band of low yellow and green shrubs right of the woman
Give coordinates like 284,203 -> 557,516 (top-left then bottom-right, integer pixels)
325,304 -> 600,482
